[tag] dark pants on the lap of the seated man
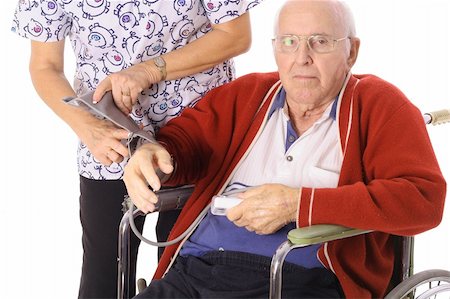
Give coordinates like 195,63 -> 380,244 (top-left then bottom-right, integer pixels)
135,251 -> 343,299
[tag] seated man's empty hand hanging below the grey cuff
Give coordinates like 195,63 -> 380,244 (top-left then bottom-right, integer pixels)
123,143 -> 173,213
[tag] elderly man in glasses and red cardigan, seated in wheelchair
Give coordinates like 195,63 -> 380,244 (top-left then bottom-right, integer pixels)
124,0 -> 446,298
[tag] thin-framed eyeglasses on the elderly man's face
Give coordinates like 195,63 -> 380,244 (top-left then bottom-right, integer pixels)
272,34 -> 350,54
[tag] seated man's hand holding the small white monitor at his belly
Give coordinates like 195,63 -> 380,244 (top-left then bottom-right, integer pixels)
227,184 -> 300,235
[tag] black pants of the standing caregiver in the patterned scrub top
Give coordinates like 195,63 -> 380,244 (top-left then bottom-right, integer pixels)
78,177 -> 178,298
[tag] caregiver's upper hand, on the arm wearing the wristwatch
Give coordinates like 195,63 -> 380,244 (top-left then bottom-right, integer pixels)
93,62 -> 161,115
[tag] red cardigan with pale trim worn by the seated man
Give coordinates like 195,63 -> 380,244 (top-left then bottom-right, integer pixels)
155,73 -> 446,298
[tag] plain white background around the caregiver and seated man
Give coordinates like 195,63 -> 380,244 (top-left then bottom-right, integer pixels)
0,0 -> 450,298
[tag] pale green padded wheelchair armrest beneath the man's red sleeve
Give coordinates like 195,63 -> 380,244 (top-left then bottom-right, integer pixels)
287,224 -> 371,246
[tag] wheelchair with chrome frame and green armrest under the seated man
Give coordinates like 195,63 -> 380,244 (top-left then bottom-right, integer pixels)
117,110 -> 450,299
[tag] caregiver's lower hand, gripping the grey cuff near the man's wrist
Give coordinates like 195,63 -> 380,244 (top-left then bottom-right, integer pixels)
79,116 -> 128,166
